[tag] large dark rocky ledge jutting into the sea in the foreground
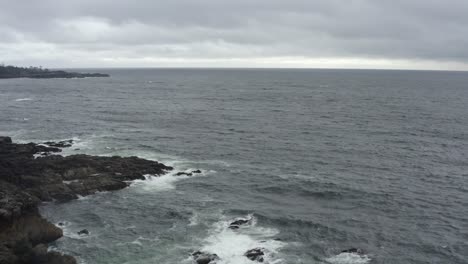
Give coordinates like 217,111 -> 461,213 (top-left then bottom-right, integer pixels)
0,136 -> 172,264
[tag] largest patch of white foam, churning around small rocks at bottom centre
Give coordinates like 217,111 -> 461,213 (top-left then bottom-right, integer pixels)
201,216 -> 284,264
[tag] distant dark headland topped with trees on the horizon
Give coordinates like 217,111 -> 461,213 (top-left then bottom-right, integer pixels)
0,65 -> 109,79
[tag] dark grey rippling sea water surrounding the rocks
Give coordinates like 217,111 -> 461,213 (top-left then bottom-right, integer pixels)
0,69 -> 468,264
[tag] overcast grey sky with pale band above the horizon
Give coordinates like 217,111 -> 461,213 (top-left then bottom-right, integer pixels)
0,0 -> 468,70
